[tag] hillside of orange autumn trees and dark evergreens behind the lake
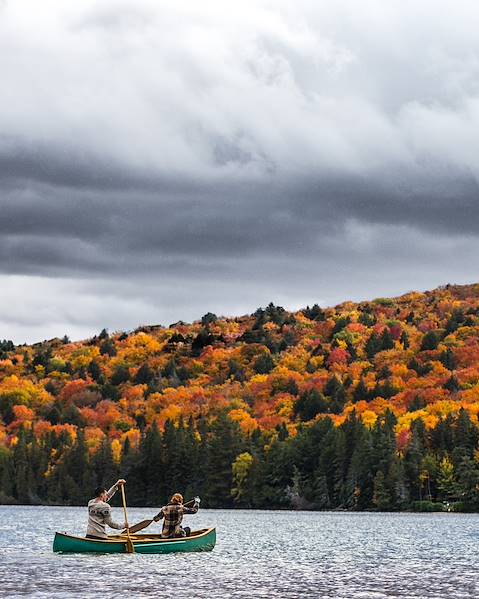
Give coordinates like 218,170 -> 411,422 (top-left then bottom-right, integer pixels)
0,285 -> 479,510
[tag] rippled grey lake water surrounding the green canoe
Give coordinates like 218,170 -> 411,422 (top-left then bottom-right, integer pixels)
0,506 -> 479,599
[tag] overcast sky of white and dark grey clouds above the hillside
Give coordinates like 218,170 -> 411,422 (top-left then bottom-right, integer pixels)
0,0 -> 479,343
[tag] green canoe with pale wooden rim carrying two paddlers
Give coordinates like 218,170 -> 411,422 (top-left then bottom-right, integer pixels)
53,528 -> 216,553
